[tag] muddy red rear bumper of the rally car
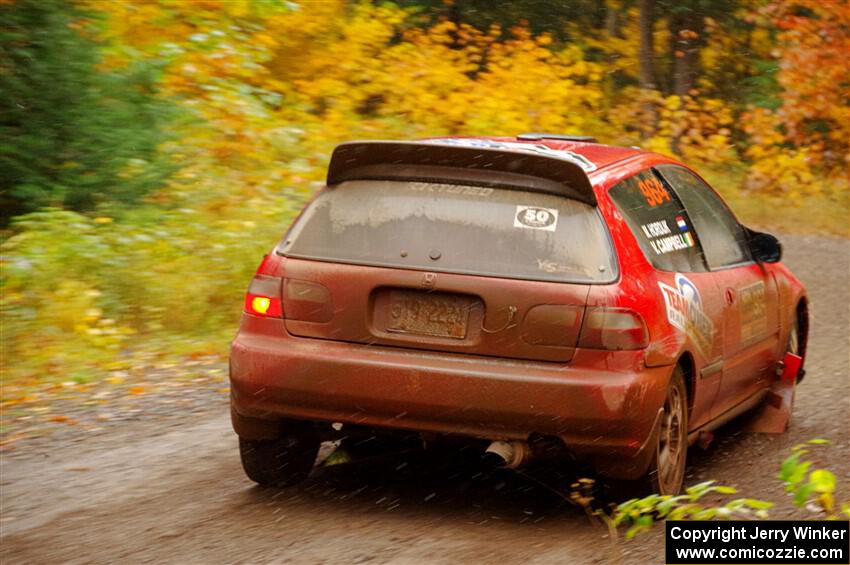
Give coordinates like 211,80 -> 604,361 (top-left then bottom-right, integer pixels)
230,315 -> 670,476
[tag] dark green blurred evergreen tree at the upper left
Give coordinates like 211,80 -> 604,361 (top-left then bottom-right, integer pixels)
0,0 -> 173,226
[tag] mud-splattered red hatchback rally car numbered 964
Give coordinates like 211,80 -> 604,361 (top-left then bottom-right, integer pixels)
230,134 -> 808,494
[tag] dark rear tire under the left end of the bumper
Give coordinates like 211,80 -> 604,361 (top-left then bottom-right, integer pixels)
239,422 -> 320,487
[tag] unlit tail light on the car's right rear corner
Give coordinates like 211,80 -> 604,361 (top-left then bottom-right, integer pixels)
578,307 -> 649,351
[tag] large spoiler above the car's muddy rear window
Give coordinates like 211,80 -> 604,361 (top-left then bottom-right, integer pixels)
327,139 -> 596,206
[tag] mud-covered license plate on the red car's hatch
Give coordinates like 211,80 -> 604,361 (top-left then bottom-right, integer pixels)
387,291 -> 472,339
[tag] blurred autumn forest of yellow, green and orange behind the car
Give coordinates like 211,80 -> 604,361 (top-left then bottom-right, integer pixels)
0,0 -> 850,390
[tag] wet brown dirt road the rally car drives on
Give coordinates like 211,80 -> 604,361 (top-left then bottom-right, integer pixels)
0,231 -> 850,564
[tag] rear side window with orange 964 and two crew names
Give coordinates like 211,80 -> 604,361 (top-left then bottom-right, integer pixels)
608,170 -> 706,272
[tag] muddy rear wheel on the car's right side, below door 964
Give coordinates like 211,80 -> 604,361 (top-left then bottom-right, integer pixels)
643,366 -> 688,495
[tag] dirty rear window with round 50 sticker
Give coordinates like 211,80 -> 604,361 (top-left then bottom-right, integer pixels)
278,181 -> 617,283
